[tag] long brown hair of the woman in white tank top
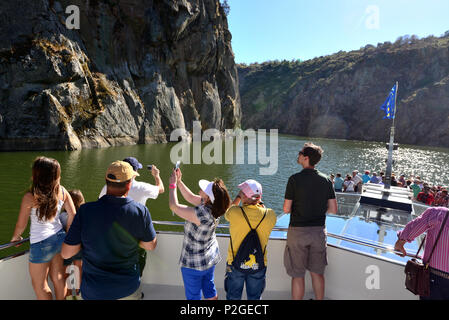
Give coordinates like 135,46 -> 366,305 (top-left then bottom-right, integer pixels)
30,157 -> 61,221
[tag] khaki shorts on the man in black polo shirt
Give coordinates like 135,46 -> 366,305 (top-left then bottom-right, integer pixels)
284,227 -> 327,278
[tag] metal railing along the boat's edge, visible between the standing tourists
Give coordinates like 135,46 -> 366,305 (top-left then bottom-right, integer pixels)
0,221 -> 422,261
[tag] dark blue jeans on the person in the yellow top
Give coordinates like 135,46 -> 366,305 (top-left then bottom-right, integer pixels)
224,265 -> 267,300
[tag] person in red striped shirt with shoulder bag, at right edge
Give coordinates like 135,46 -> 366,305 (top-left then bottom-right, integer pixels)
394,207 -> 449,300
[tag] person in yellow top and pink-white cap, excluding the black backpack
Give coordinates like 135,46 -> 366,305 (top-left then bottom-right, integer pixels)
225,179 -> 276,300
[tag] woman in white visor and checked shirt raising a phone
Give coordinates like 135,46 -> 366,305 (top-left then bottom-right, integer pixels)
169,169 -> 231,300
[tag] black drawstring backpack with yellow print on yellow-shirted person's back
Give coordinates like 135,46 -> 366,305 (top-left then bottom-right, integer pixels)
230,207 -> 267,273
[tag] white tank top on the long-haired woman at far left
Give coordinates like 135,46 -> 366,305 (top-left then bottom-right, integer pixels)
30,200 -> 64,244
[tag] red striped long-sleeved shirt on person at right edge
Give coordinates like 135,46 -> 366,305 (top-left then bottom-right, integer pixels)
398,207 -> 449,273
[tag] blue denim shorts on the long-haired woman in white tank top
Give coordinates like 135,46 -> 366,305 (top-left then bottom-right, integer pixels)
29,230 -> 65,263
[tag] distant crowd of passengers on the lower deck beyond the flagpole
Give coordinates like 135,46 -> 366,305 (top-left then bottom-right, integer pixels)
330,170 -> 449,207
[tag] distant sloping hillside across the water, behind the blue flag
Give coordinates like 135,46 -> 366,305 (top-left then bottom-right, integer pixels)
238,34 -> 449,147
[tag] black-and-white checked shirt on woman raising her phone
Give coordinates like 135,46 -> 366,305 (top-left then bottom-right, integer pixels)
179,204 -> 221,271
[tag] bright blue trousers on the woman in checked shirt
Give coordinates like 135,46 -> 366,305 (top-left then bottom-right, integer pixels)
181,266 -> 217,300
